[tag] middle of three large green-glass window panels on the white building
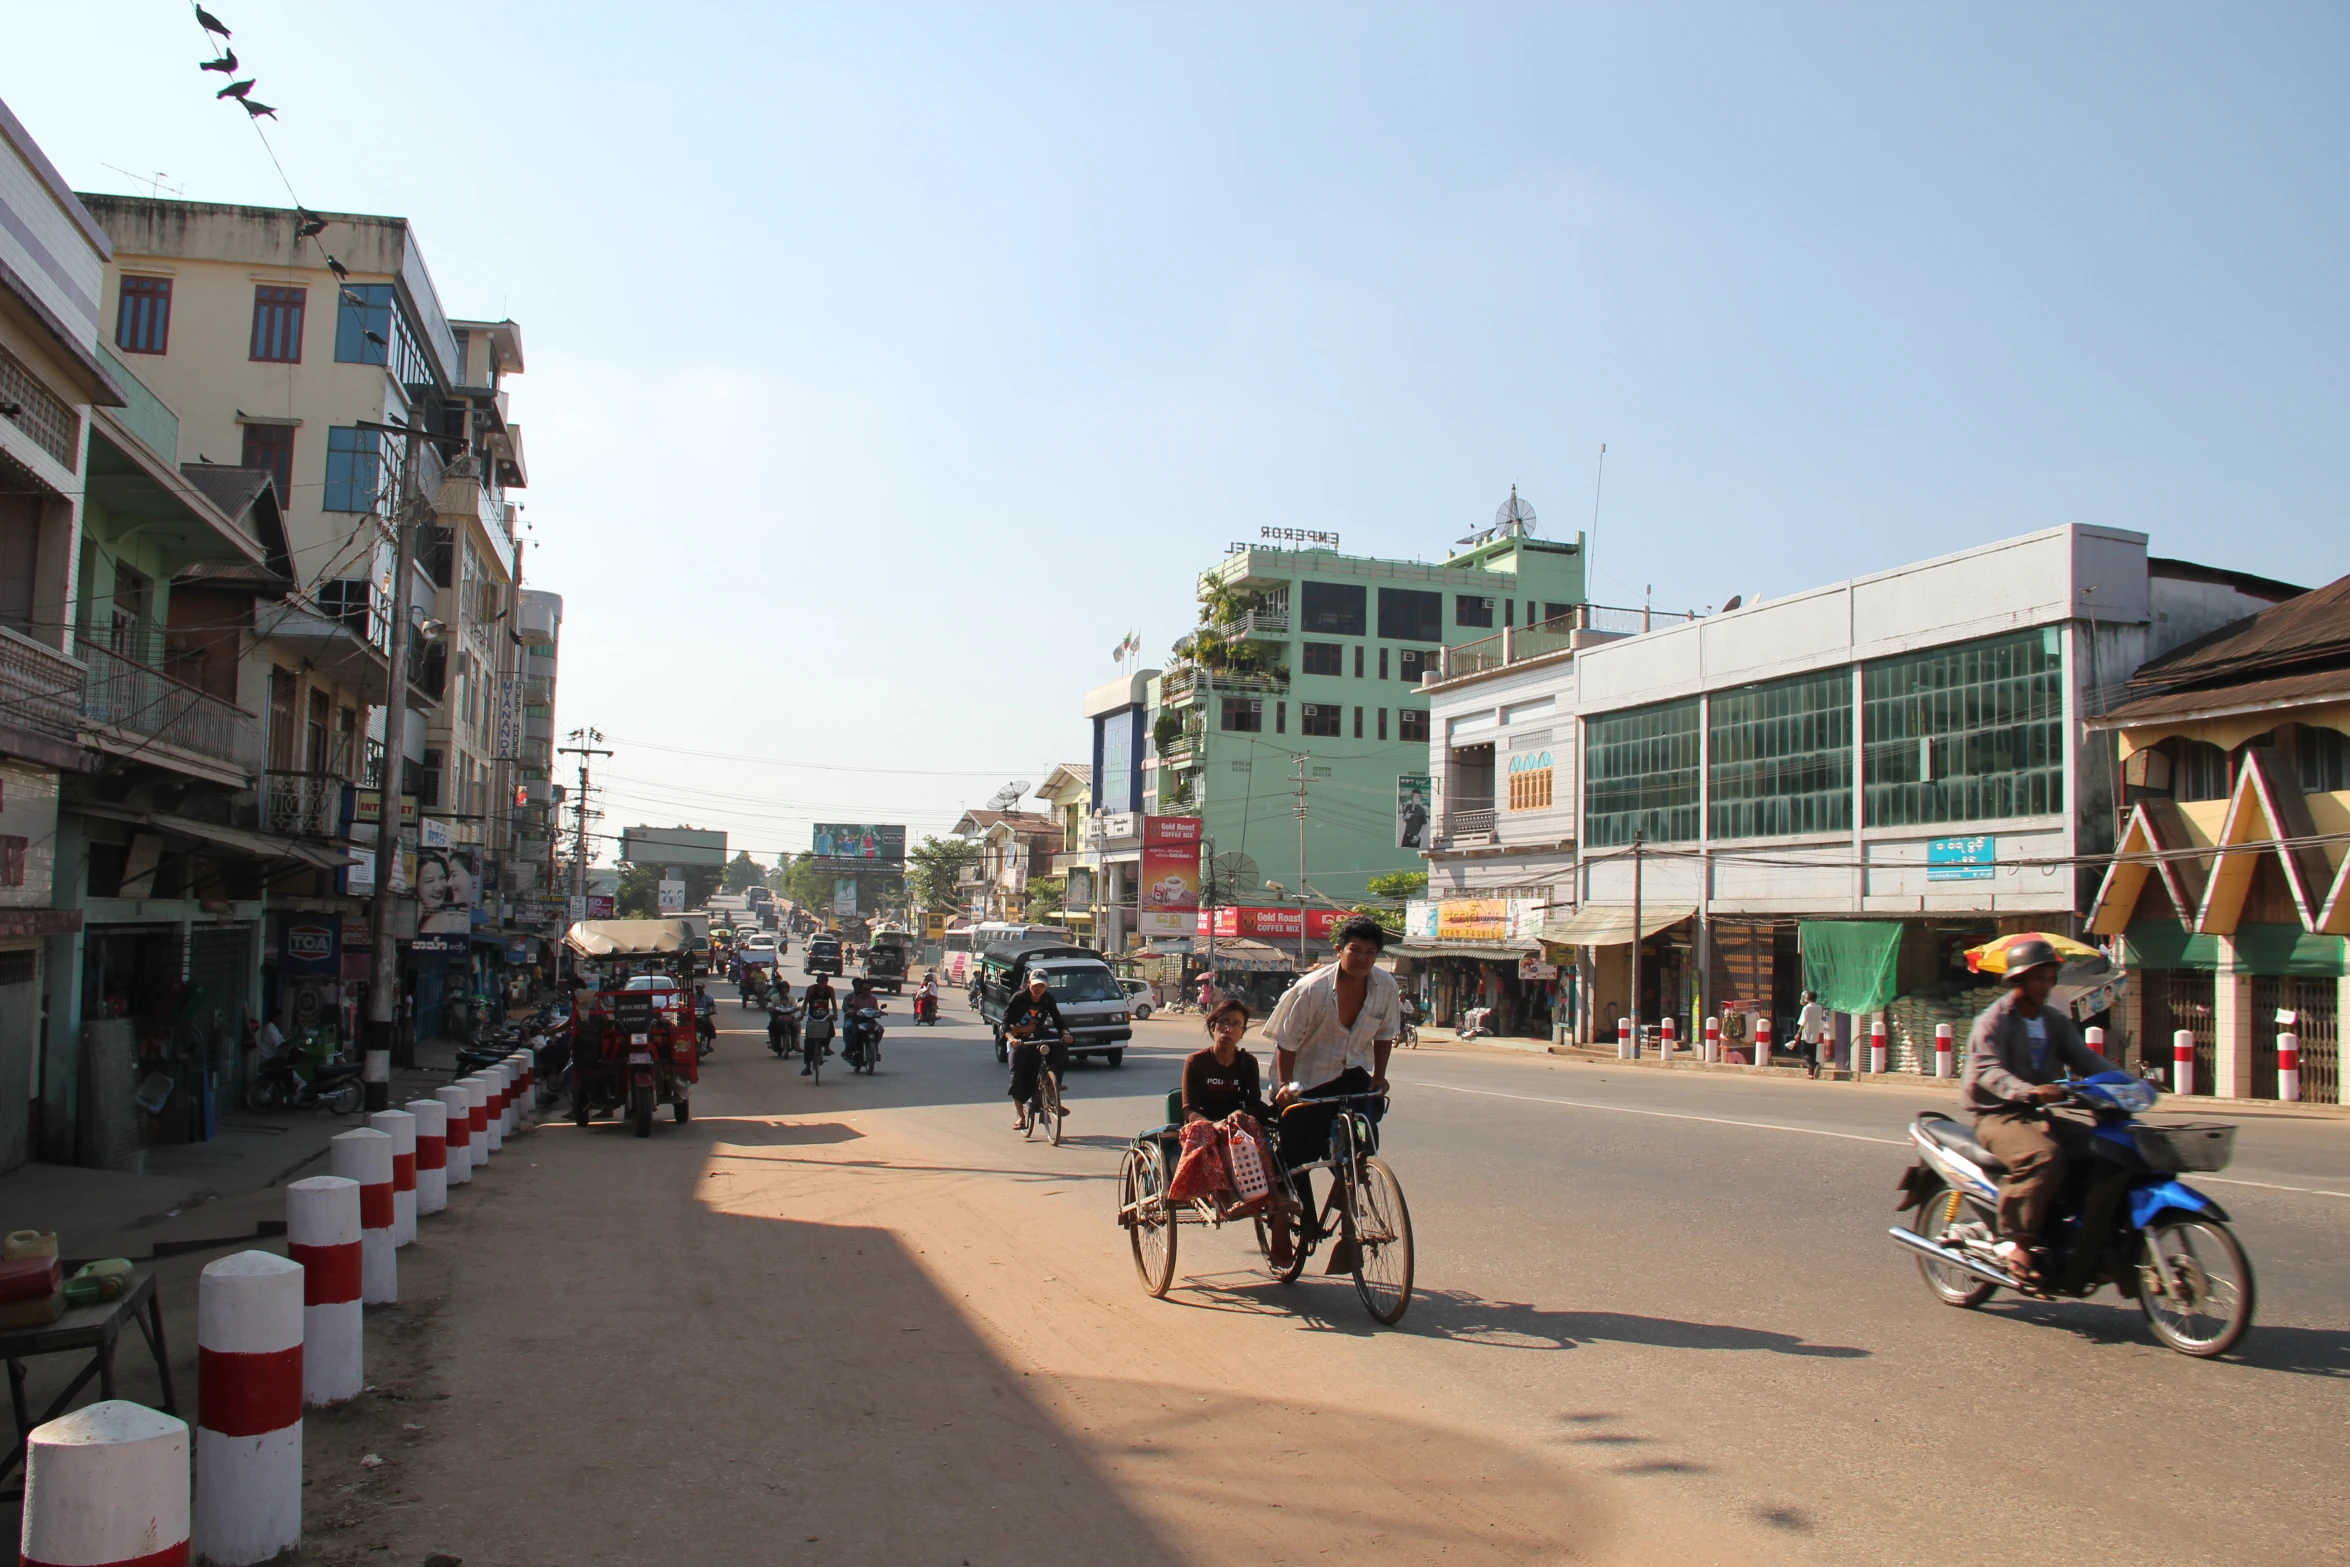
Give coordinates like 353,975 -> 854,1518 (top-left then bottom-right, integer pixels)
1706,667 -> 1852,839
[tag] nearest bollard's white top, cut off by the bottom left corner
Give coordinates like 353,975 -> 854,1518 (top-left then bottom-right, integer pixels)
16,1398 -> 188,1567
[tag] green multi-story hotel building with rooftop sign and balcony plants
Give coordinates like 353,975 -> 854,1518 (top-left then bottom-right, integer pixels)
1142,521 -> 1586,935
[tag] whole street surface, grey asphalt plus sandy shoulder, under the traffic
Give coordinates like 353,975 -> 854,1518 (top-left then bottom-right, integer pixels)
320,951 -> 2350,1565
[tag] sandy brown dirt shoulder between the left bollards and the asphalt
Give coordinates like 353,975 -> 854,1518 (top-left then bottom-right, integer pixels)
303,1036 -> 1798,1567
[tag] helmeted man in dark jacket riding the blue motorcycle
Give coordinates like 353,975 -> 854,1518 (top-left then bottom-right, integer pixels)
1962,940 -> 2113,1285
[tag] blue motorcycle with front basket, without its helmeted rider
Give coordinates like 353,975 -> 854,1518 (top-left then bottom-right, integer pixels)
1892,1071 -> 2254,1358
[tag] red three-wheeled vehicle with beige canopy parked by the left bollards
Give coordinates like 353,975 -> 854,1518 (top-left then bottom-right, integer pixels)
564,919 -> 700,1137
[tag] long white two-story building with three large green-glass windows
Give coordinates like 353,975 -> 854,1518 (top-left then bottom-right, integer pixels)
1429,526 -> 2298,1055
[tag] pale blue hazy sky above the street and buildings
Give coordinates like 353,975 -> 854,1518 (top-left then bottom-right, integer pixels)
0,0 -> 2350,858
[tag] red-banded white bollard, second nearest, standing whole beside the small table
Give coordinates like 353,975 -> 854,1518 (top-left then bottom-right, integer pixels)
195,1240 -> 305,1567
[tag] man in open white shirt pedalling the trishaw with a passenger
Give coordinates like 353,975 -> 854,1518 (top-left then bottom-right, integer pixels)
1262,914 -> 1403,1273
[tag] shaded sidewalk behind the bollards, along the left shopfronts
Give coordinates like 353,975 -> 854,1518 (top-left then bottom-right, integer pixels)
0,1048 -> 451,1262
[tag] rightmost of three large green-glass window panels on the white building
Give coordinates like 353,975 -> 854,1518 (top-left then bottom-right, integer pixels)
1861,625 -> 2063,827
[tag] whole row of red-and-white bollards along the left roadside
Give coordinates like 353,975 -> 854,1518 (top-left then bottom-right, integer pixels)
19,1050 -> 538,1567
